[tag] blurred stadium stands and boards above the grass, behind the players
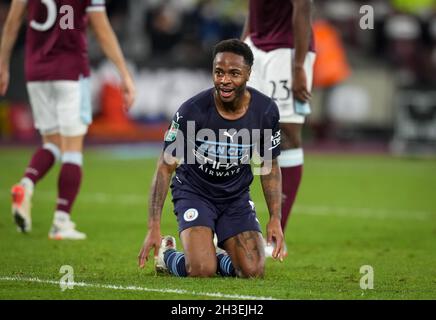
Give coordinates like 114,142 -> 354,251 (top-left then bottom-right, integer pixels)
0,0 -> 436,153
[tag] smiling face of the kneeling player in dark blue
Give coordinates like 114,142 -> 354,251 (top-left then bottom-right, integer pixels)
213,52 -> 250,103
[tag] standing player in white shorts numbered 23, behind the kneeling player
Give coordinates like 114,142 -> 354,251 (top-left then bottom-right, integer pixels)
242,0 -> 315,256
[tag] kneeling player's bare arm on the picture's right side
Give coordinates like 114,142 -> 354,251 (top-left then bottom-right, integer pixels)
260,159 -> 284,261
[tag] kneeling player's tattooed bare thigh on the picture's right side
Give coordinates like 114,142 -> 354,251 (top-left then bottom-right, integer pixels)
224,231 -> 265,278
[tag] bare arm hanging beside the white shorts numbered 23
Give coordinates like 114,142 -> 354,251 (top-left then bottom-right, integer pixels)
290,0 -> 312,102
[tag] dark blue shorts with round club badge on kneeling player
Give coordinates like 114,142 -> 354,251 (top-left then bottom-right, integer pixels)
173,192 -> 261,247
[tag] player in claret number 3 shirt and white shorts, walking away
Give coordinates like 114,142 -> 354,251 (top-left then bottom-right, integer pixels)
0,0 -> 135,240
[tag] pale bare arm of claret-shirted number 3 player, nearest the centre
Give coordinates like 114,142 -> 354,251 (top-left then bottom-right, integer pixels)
88,11 -> 136,109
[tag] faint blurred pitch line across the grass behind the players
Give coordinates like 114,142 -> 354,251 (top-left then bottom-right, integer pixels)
0,190 -> 436,221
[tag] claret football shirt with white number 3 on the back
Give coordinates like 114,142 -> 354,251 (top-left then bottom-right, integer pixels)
21,0 -> 105,81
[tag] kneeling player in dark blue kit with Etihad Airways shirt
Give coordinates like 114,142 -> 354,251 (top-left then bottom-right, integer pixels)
138,39 -> 283,277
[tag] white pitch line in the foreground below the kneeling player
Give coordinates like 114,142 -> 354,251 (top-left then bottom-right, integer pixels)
0,277 -> 276,300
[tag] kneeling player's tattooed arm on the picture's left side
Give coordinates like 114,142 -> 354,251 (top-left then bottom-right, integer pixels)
138,153 -> 177,268
